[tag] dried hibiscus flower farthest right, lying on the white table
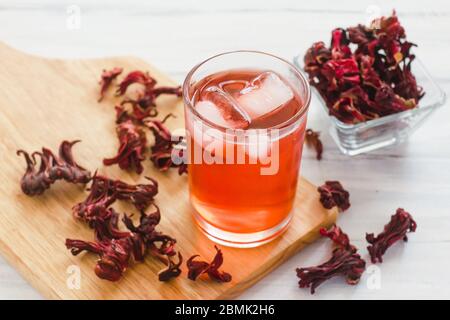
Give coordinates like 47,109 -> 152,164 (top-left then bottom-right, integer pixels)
366,208 -> 417,263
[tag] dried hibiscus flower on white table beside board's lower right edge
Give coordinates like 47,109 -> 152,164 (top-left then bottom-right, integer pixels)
296,226 -> 366,294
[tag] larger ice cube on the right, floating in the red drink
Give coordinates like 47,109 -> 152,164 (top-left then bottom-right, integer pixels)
237,71 -> 294,119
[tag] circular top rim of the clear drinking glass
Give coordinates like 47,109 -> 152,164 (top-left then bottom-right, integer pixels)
182,50 -> 311,131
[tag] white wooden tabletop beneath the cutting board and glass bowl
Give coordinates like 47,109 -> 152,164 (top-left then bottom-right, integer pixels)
0,0 -> 450,299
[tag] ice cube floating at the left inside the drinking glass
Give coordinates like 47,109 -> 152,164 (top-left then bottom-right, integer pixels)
195,86 -> 250,129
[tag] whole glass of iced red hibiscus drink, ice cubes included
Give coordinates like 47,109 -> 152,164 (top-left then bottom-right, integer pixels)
183,51 -> 310,247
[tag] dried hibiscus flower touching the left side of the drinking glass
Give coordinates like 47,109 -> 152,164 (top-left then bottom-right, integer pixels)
145,114 -> 187,175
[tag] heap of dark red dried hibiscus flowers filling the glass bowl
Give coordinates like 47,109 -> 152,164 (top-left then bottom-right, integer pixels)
304,11 -> 424,123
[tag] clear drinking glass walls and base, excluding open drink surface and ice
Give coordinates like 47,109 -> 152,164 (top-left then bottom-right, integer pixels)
183,51 -> 310,247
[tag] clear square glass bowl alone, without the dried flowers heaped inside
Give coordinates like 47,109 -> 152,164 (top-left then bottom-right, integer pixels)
294,55 -> 446,156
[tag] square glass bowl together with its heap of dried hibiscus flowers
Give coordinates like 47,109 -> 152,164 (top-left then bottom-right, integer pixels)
294,11 -> 445,155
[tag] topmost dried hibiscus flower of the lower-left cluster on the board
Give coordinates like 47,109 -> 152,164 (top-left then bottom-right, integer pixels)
72,174 -> 158,226
